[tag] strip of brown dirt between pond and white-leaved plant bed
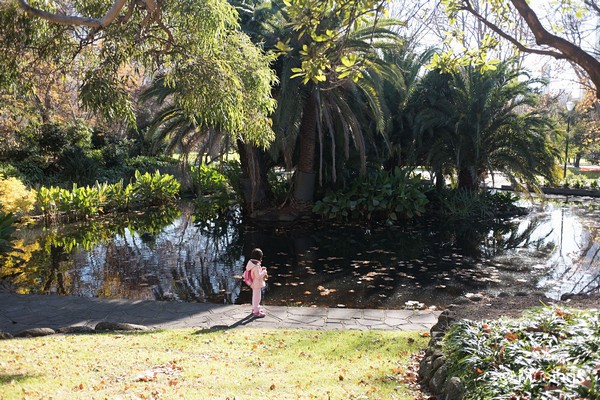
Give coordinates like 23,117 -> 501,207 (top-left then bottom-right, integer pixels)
449,293 -> 600,320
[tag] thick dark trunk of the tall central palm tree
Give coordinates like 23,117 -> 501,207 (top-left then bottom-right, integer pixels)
294,90 -> 317,204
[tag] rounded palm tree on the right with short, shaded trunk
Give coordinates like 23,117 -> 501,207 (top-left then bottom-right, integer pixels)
416,61 -> 558,190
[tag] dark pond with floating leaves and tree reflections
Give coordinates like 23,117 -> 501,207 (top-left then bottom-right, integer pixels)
0,198 -> 600,309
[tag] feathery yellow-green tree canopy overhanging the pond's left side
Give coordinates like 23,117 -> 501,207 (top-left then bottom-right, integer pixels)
0,0 -> 276,146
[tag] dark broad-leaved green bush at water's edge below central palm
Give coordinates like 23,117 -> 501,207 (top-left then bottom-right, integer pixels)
313,168 -> 428,225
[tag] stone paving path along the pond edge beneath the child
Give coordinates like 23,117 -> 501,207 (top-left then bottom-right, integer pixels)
0,293 -> 440,335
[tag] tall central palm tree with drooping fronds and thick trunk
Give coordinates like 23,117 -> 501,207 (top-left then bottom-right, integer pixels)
266,3 -> 399,208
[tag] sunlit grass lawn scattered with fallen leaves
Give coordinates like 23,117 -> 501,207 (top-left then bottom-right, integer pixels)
0,329 -> 428,400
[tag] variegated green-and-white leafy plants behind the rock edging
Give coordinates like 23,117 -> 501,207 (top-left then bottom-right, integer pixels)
443,307 -> 600,400
